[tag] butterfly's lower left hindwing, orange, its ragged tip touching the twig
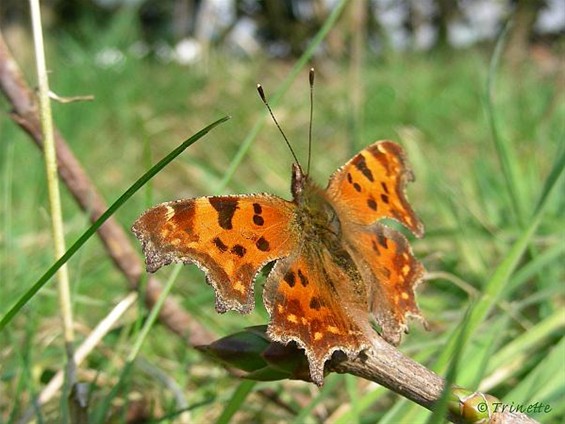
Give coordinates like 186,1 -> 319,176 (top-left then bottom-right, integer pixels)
264,246 -> 369,385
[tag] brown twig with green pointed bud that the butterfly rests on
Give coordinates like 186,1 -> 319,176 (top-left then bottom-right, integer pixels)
204,325 -> 536,423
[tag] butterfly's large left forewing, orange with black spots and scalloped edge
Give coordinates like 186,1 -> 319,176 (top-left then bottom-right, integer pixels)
132,194 -> 297,312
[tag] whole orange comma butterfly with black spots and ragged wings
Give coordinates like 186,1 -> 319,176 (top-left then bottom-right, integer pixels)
132,72 -> 425,385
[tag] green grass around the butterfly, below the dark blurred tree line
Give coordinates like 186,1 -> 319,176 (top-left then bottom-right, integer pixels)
0,19 -> 565,423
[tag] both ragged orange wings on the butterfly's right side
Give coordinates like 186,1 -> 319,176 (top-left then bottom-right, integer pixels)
327,141 -> 424,344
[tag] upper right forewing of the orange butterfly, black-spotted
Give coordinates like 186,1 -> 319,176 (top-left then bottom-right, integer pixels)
327,141 -> 424,237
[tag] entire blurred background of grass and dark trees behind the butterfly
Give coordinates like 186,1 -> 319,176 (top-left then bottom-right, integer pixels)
0,0 -> 565,423
